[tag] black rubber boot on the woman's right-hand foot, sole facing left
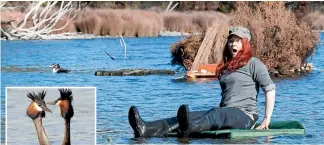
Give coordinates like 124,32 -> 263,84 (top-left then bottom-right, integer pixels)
177,105 -> 211,138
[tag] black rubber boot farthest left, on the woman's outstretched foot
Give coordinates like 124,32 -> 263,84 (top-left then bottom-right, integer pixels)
128,106 -> 179,138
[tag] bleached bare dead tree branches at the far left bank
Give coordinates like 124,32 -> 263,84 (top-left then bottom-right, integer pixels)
3,1 -> 80,39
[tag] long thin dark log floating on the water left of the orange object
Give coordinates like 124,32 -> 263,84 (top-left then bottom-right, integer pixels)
95,69 -> 175,76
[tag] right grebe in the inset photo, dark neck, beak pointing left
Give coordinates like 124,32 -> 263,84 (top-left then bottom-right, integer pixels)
47,89 -> 74,145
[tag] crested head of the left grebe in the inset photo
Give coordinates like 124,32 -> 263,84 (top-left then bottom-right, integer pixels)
26,91 -> 52,119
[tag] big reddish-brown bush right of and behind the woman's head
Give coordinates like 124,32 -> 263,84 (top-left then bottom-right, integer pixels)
230,2 -> 318,74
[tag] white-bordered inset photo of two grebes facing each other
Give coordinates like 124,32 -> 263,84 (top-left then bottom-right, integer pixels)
6,87 -> 96,145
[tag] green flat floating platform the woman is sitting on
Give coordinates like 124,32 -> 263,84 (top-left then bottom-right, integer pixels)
198,121 -> 305,139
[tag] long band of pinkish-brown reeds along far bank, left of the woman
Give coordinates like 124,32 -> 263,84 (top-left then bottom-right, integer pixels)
1,7 -> 229,37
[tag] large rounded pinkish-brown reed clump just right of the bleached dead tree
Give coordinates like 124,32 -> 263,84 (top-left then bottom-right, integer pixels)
75,8 -> 163,37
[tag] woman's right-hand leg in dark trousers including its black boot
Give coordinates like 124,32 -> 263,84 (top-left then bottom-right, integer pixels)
177,105 -> 254,138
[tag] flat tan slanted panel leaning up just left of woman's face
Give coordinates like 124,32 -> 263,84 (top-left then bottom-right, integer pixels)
191,21 -> 229,70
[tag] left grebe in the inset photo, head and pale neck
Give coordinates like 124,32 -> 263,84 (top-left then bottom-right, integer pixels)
26,91 -> 52,145
